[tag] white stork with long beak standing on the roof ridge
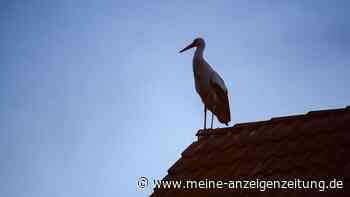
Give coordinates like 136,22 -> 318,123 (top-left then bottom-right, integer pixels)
179,38 -> 231,131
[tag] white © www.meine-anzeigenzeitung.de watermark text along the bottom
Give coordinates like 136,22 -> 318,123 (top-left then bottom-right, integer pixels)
137,177 -> 344,192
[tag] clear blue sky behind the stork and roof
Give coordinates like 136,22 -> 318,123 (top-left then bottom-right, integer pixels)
0,0 -> 350,197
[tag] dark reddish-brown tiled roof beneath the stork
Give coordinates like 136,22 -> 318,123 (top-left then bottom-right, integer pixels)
151,106 -> 350,197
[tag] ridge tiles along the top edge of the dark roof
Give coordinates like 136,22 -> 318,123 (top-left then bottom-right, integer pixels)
196,105 -> 350,137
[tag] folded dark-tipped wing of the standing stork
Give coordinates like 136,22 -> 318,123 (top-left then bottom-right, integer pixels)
210,71 -> 231,125
